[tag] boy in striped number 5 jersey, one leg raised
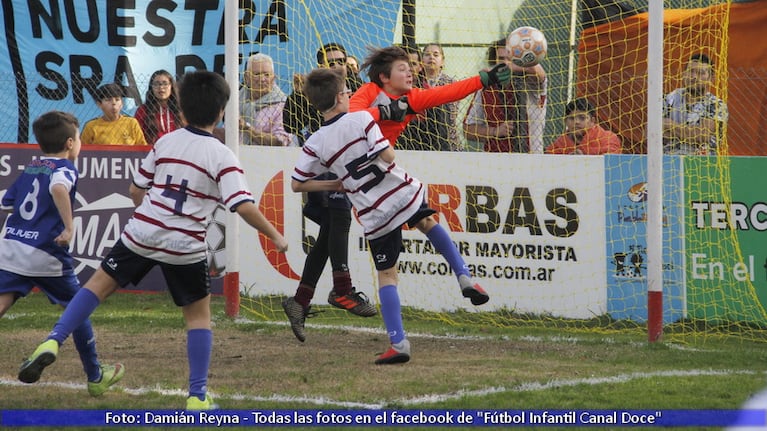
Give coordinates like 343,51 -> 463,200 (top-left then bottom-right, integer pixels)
291,69 -> 490,364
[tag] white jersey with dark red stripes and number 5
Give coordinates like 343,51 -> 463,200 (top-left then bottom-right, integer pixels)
293,111 -> 425,239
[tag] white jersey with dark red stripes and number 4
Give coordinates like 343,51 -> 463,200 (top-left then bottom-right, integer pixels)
121,127 -> 254,265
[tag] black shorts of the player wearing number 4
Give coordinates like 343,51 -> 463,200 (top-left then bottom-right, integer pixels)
101,240 -> 210,307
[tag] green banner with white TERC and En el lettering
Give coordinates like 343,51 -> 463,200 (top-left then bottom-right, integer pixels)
685,157 -> 767,323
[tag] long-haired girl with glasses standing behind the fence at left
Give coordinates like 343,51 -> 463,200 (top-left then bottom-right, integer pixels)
133,69 -> 183,145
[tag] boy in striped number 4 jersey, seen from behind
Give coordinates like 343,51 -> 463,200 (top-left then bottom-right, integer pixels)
22,71 -> 288,410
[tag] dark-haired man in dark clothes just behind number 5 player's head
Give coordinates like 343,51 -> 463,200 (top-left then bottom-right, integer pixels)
282,42 -> 363,145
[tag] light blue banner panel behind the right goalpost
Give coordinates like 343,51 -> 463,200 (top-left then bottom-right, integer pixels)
604,155 -> 686,323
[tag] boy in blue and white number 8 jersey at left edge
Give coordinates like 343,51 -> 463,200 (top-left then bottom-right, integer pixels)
0,111 -> 125,397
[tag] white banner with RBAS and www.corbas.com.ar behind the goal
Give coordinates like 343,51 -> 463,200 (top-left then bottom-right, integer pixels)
239,147 -> 607,318
